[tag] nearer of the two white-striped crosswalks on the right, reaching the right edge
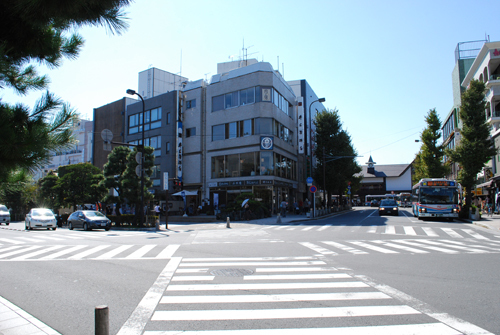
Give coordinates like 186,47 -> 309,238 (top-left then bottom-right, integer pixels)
299,239 -> 500,256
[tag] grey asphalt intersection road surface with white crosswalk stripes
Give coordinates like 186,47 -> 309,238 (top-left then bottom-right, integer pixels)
0,208 -> 500,335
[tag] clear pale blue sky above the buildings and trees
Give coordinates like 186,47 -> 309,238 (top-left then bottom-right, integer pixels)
0,0 -> 500,164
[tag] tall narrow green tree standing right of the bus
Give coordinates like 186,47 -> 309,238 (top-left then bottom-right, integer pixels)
446,80 -> 497,215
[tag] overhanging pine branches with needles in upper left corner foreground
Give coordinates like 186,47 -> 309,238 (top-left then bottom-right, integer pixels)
0,0 -> 130,182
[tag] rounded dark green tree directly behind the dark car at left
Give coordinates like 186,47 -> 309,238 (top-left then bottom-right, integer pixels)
55,163 -> 106,210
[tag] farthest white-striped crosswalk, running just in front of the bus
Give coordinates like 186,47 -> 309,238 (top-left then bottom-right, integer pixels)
253,224 -> 500,240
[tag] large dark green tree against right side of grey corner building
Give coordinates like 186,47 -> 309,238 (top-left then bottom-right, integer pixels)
314,110 -> 361,206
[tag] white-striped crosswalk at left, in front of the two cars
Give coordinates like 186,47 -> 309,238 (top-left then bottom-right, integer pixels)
0,244 -> 180,262
